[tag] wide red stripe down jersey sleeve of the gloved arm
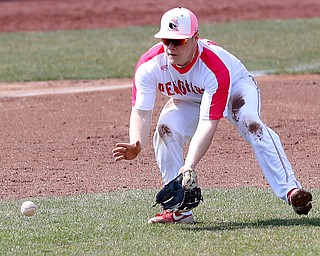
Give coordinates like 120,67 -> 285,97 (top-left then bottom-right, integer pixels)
200,48 -> 230,120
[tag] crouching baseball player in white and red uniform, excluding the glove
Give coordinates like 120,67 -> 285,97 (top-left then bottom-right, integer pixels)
113,7 -> 312,223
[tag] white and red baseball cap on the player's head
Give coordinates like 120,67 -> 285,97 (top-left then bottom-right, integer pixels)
154,7 -> 198,39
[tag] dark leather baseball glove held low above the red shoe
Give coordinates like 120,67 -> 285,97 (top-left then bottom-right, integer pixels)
153,170 -> 203,211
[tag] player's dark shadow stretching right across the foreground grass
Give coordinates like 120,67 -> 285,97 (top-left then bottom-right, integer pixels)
181,218 -> 320,231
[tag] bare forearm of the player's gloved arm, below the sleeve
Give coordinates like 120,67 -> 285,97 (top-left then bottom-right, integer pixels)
180,119 -> 219,172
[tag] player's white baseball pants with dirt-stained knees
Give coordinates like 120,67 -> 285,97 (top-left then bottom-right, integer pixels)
153,77 -> 301,201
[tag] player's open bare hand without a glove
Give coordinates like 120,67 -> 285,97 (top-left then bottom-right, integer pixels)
112,141 -> 142,161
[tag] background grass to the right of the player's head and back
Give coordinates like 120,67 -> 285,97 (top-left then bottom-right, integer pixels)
202,18 -> 320,74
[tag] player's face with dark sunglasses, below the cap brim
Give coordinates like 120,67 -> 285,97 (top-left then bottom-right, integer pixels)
161,35 -> 198,66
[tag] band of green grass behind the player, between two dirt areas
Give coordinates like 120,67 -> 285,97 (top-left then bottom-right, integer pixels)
0,18 -> 320,81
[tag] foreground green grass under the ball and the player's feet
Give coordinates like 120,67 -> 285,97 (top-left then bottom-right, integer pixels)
0,188 -> 320,255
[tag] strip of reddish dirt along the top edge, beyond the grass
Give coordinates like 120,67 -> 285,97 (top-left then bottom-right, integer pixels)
0,0 -> 320,32
